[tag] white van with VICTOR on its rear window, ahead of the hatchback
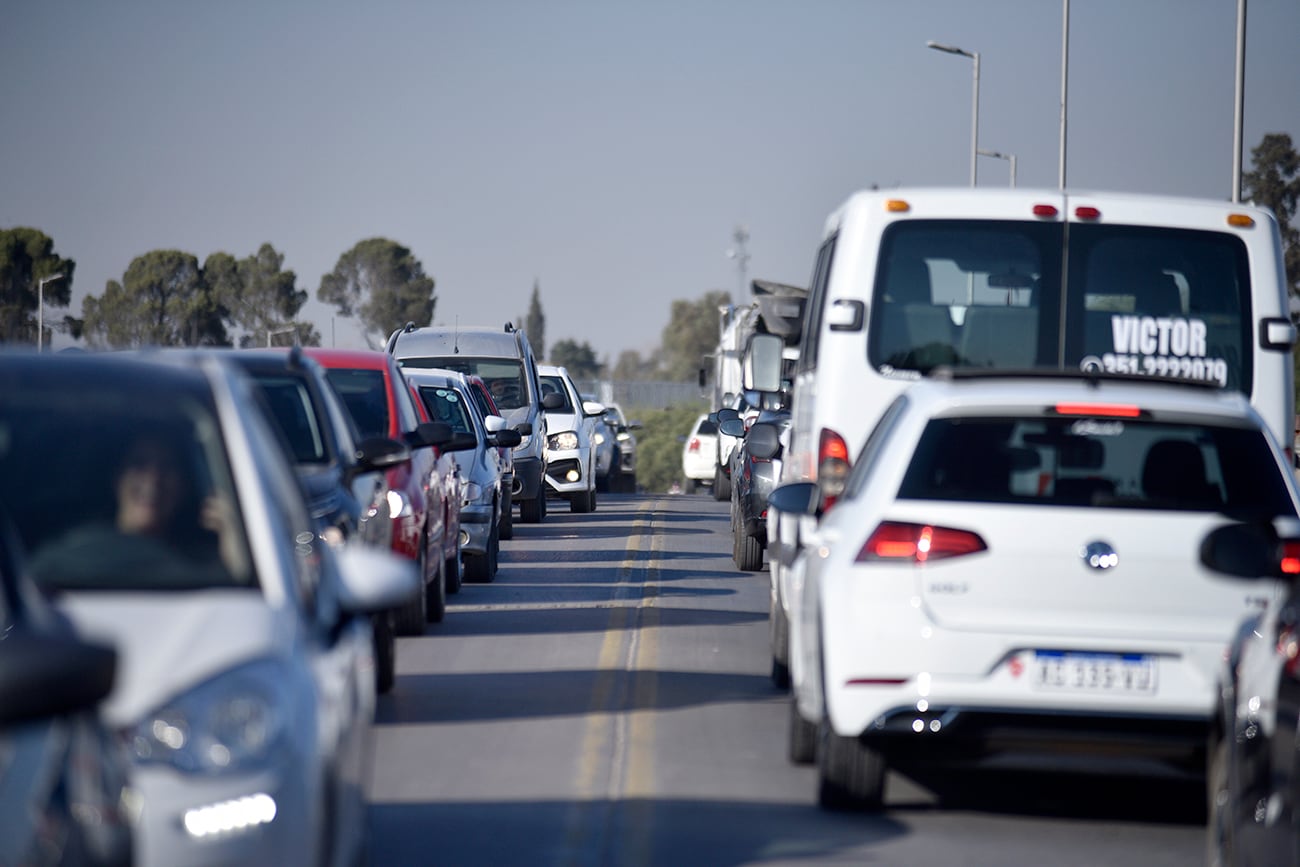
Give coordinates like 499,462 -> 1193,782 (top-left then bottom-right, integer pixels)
770,187 -> 1296,675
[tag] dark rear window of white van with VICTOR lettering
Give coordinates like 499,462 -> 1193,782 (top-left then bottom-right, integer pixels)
867,220 -> 1253,394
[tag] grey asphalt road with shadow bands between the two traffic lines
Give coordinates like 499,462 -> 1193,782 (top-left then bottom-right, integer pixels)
368,494 -> 1204,867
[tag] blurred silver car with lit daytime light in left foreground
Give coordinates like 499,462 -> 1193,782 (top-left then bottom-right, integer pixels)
0,351 -> 419,867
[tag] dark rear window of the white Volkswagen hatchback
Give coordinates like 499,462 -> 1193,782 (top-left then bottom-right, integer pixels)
898,417 -> 1295,517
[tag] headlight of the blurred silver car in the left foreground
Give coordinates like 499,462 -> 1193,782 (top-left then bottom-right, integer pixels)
131,660 -> 291,773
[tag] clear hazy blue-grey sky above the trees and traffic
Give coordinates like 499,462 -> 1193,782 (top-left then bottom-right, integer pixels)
0,0 -> 1300,360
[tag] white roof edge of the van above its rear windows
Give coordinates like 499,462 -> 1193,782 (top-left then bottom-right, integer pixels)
826,186 -> 1274,237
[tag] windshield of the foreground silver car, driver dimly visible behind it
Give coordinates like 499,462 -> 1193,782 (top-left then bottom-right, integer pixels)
0,387 -> 256,590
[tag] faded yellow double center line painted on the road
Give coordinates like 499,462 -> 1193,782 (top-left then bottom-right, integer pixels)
566,500 -> 663,866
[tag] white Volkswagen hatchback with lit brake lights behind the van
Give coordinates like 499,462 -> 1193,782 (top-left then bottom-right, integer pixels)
772,372 -> 1300,809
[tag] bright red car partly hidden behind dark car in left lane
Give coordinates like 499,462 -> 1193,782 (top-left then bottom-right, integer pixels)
303,347 -> 460,636
